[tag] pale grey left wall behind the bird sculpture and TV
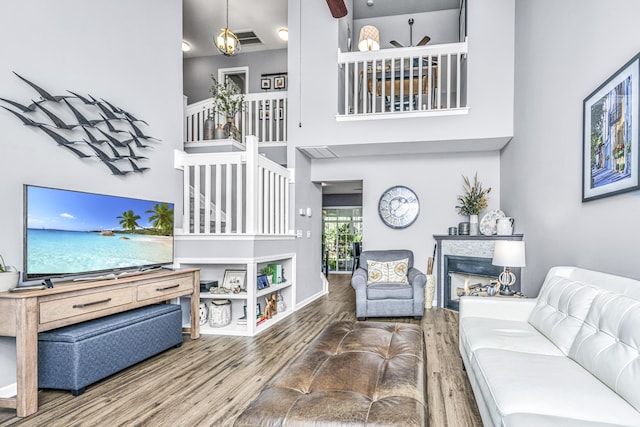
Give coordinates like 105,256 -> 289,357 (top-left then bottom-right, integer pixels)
0,0 -> 182,392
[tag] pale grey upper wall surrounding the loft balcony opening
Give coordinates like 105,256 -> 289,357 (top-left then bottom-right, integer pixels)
288,0 -> 514,150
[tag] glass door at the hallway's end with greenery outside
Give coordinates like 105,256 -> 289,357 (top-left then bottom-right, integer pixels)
322,207 -> 362,273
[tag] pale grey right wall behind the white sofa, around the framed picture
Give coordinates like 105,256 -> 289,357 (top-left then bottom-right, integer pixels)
502,0 -> 640,295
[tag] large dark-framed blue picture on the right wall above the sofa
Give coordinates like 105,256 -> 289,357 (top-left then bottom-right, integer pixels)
582,50 -> 640,202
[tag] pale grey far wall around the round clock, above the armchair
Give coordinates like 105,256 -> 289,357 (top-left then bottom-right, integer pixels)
311,151 -> 500,272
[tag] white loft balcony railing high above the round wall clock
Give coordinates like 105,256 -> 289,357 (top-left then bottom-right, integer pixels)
338,40 -> 467,120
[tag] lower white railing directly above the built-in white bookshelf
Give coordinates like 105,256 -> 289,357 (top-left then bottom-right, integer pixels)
176,136 -> 293,235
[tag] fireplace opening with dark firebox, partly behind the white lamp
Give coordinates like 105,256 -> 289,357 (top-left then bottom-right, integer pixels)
443,255 -> 502,310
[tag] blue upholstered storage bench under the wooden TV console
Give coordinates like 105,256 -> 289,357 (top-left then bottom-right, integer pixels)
38,304 -> 182,396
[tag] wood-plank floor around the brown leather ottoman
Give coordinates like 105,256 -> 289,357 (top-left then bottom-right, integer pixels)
0,275 -> 482,427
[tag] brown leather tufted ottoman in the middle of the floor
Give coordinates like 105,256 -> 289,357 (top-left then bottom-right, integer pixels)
234,322 -> 427,427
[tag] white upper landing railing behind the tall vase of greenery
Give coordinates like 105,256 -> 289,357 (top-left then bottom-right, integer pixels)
184,91 -> 288,144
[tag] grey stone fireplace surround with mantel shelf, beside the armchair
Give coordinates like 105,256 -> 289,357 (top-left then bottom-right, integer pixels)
433,234 -> 524,310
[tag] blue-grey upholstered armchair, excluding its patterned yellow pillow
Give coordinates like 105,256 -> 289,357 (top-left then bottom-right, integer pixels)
351,250 -> 427,320
